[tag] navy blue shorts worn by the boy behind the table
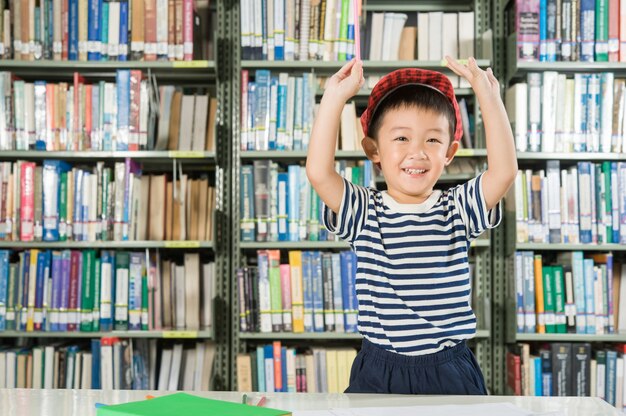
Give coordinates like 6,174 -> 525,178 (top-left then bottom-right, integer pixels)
345,339 -> 487,395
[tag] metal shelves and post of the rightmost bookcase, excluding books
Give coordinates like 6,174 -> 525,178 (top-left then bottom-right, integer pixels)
493,0 -> 626,404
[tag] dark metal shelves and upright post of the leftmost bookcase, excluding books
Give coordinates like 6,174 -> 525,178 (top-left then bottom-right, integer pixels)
0,0 -> 231,390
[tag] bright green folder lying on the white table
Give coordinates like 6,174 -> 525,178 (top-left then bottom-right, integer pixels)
97,393 -> 291,416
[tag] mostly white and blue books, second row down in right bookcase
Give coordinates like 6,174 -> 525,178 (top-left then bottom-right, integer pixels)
506,71 -> 626,153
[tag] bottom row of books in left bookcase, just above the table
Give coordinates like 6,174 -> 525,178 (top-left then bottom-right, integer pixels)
0,337 -> 215,391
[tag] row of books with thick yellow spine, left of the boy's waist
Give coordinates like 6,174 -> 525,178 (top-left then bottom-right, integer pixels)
237,250 -> 357,333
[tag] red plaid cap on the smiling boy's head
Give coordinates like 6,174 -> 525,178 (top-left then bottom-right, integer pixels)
361,68 -> 463,141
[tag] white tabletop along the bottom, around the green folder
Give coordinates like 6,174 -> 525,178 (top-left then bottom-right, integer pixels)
0,389 -> 622,416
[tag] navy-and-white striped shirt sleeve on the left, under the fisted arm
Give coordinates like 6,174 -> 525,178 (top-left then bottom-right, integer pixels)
322,178 -> 369,243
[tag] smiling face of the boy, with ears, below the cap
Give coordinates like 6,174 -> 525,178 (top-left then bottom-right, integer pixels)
363,105 -> 458,204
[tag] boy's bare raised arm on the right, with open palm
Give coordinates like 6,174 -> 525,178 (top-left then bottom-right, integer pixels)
446,57 -> 517,209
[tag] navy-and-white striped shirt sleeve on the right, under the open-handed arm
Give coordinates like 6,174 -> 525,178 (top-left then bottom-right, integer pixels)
452,173 -> 502,241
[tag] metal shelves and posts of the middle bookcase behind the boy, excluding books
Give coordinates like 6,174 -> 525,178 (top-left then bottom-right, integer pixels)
230,0 -> 499,394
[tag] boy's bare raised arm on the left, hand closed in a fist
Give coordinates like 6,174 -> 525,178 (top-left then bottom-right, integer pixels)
306,59 -> 365,213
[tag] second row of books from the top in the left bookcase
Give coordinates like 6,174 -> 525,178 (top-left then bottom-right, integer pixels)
0,69 -> 217,151
